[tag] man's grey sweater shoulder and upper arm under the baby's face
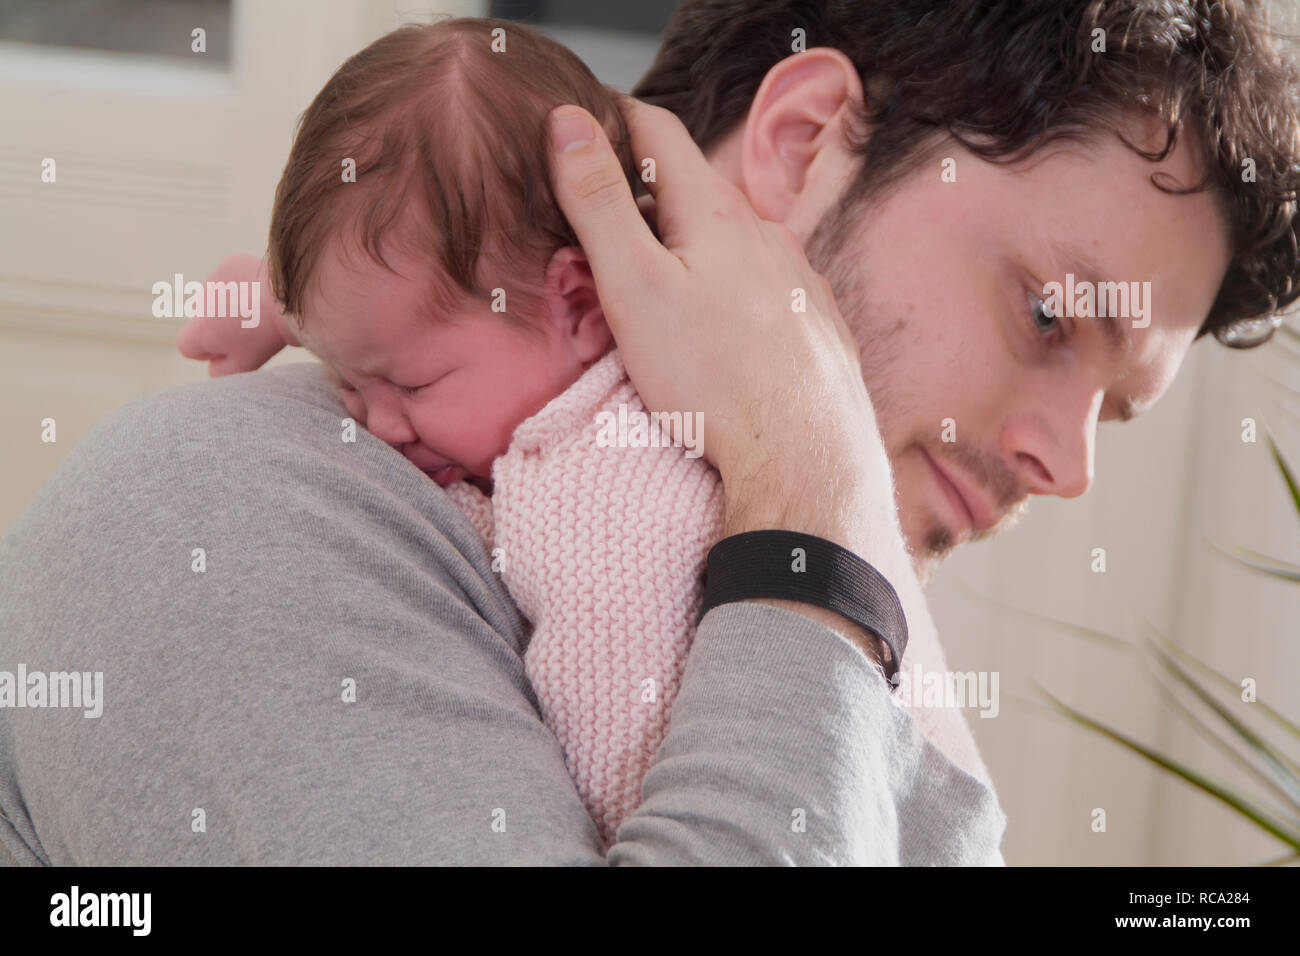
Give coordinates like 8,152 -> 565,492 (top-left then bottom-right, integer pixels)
0,367 -> 543,865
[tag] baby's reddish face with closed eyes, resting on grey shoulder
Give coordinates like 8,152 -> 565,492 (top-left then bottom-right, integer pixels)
300,243 -> 584,486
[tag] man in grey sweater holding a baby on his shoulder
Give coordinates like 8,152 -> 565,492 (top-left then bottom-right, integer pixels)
0,3 -> 1300,864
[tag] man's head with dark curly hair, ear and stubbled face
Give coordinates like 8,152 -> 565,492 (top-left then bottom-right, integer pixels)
633,0 -> 1300,576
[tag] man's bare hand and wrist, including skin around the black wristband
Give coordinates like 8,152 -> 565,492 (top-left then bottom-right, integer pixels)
551,99 -> 932,661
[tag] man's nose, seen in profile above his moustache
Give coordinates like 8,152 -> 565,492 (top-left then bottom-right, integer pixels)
1004,390 -> 1102,498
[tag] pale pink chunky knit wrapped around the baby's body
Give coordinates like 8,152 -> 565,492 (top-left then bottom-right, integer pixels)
446,350 -> 988,847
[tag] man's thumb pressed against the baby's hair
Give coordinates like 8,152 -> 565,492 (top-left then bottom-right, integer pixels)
550,105 -> 667,303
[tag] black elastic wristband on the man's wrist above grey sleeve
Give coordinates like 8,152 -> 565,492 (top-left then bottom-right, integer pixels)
699,529 -> 907,685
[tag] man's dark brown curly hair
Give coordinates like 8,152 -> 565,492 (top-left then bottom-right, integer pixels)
633,0 -> 1300,349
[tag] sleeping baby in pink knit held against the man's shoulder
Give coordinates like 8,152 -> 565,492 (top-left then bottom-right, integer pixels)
179,20 -> 987,847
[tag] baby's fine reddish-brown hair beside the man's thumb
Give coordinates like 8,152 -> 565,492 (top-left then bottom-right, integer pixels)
267,18 -> 636,328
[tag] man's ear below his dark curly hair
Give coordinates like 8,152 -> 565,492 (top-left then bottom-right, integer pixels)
741,47 -> 862,233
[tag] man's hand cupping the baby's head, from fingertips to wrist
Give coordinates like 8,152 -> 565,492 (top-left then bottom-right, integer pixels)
551,99 -> 875,486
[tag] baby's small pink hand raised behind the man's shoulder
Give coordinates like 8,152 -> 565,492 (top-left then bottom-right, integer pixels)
176,255 -> 294,377
